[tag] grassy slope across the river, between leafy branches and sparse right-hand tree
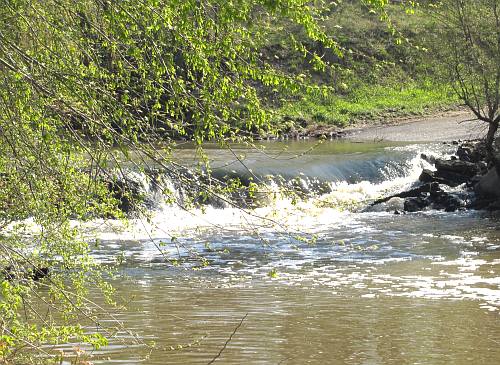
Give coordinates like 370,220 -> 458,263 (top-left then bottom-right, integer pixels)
271,1 -> 458,132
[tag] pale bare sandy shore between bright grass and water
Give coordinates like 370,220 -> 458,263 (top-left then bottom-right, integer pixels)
345,110 -> 487,142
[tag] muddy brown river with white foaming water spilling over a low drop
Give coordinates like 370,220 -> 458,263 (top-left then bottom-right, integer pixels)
60,141 -> 500,365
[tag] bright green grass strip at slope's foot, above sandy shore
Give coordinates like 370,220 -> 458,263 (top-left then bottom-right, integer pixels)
276,83 -> 458,127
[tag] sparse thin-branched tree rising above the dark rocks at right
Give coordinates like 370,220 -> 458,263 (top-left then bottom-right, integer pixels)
428,0 -> 500,150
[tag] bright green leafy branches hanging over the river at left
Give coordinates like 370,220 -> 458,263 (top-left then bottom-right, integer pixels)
0,0 -> 387,364
